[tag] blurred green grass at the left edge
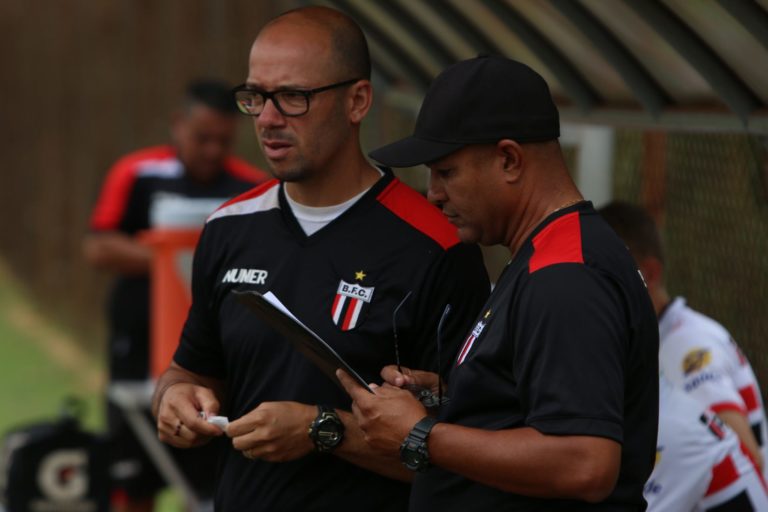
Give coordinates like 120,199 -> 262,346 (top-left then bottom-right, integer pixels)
0,265 -> 183,512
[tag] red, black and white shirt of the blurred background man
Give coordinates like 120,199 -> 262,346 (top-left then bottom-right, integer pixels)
90,145 -> 267,380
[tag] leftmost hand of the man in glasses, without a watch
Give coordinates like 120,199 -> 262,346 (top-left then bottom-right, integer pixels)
157,382 -> 224,448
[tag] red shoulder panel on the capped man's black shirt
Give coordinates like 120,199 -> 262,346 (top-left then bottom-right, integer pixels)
528,212 -> 584,274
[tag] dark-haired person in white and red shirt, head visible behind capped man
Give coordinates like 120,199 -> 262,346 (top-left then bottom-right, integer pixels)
600,201 -> 768,476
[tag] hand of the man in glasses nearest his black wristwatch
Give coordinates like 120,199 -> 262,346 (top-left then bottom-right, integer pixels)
226,402 -> 317,462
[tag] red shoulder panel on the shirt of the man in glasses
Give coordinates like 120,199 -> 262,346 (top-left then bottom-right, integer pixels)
377,179 -> 460,249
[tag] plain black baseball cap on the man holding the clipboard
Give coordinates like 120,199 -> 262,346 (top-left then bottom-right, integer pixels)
369,56 -> 560,167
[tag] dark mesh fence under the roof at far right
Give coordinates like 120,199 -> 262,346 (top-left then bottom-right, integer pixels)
614,131 -> 768,386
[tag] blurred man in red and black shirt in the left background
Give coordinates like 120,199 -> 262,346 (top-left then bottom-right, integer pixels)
83,80 -> 267,512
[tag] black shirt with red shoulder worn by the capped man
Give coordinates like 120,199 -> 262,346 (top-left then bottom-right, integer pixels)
410,202 -> 658,512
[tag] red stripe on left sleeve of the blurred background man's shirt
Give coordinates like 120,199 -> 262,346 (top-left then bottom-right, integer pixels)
90,146 -> 176,231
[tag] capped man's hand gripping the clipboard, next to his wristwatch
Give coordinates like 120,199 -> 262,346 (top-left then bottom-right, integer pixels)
336,370 -> 427,455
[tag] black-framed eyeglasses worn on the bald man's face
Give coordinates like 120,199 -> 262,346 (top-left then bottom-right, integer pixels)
232,78 -> 361,117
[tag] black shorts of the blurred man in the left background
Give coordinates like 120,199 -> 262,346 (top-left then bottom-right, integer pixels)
108,402 -> 219,500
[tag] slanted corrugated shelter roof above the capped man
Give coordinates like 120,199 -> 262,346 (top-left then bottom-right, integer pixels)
324,0 -> 768,133
